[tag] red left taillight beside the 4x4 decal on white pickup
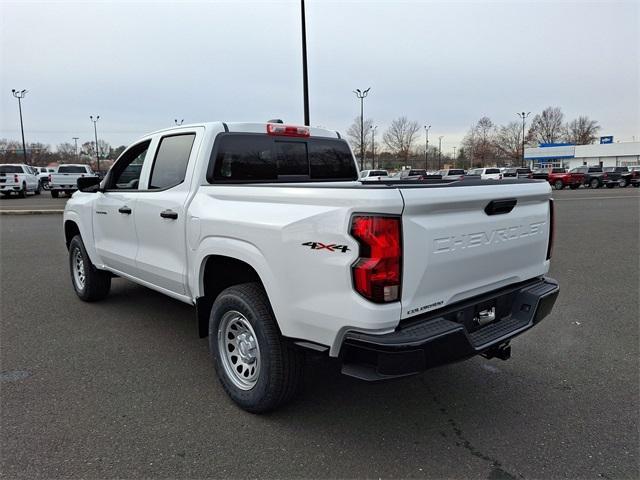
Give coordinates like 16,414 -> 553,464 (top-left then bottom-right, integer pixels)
351,215 -> 402,303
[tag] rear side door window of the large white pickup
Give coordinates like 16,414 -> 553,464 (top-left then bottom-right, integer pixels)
149,133 -> 196,190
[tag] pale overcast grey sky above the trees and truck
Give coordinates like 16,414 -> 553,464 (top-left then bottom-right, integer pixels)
0,0 -> 640,152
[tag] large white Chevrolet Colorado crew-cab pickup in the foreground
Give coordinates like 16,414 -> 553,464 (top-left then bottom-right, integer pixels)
64,122 -> 559,412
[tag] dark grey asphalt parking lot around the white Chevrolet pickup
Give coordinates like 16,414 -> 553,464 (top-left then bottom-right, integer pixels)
0,188 -> 640,479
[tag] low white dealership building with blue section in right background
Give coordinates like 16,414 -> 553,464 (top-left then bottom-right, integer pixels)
524,142 -> 640,169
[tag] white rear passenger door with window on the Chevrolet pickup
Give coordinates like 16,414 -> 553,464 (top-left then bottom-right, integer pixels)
135,128 -> 204,294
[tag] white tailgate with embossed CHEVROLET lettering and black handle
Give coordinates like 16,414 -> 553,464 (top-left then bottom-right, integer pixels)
400,181 -> 551,318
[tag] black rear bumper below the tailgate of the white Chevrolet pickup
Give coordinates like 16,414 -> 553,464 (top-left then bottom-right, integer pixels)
340,278 -> 560,380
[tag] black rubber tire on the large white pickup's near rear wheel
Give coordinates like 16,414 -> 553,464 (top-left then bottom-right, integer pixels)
209,283 -> 304,413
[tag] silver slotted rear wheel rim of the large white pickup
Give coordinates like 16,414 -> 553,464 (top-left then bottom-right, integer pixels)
218,310 -> 261,390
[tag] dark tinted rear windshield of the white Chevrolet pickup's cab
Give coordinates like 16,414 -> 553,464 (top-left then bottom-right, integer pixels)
207,133 -> 358,182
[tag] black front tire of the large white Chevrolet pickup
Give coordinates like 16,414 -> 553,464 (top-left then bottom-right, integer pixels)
69,235 -> 111,302
